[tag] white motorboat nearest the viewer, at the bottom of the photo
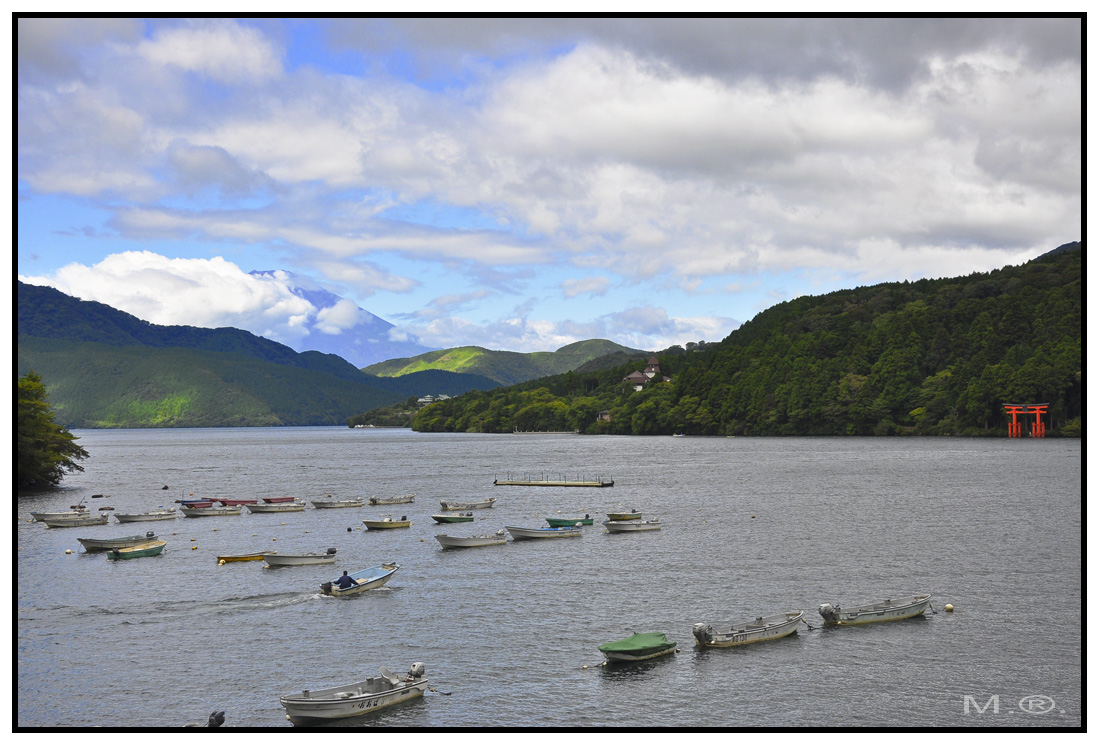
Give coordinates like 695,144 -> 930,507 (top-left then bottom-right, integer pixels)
279,663 -> 428,724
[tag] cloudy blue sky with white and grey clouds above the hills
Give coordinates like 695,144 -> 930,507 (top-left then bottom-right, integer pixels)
16,19 -> 1083,352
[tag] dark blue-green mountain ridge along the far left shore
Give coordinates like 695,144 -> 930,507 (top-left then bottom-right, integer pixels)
16,282 -> 497,427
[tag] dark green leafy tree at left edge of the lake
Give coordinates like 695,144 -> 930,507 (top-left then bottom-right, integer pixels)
15,370 -> 88,489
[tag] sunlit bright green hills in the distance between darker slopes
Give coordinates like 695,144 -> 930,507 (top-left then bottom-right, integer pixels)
363,338 -> 645,386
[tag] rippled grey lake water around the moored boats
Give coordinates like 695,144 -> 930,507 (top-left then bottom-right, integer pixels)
14,427 -> 1084,727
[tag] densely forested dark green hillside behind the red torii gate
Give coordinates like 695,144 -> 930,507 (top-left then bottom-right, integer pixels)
413,243 -> 1084,436
